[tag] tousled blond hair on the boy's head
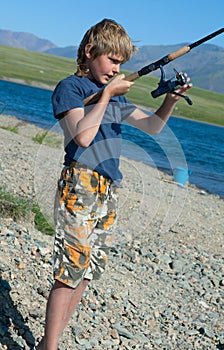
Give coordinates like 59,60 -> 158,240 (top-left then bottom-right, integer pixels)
77,18 -> 137,75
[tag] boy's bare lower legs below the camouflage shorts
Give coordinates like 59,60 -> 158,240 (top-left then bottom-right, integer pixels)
37,279 -> 89,350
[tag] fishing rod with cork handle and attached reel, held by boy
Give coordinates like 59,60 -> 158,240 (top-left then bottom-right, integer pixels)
84,28 -> 224,105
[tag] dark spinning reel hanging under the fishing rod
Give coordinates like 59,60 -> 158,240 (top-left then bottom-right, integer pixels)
151,66 -> 193,105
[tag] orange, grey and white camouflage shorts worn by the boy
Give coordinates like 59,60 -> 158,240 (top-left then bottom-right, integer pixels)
54,162 -> 119,288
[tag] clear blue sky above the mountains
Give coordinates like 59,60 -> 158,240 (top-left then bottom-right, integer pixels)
0,0 -> 224,47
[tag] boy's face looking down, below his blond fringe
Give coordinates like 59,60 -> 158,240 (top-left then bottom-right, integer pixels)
88,54 -> 122,84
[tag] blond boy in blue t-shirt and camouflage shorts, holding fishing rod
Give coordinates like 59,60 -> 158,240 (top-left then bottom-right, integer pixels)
37,19 -> 191,350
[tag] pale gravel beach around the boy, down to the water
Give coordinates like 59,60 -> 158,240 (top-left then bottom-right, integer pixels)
0,115 -> 224,350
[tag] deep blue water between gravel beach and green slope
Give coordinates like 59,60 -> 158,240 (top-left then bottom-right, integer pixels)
0,80 -> 224,198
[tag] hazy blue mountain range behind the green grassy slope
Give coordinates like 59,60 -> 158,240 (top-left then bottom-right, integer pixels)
0,30 -> 224,93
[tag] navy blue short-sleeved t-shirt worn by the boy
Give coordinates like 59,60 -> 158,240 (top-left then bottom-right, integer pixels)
52,75 -> 136,185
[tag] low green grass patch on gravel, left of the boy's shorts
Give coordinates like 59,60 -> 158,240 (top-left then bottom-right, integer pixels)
0,188 -> 54,235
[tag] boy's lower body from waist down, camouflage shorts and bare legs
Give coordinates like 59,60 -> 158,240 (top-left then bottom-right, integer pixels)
37,169 -> 118,350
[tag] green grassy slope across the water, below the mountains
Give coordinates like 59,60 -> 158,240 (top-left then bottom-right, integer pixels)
0,45 -> 224,125
